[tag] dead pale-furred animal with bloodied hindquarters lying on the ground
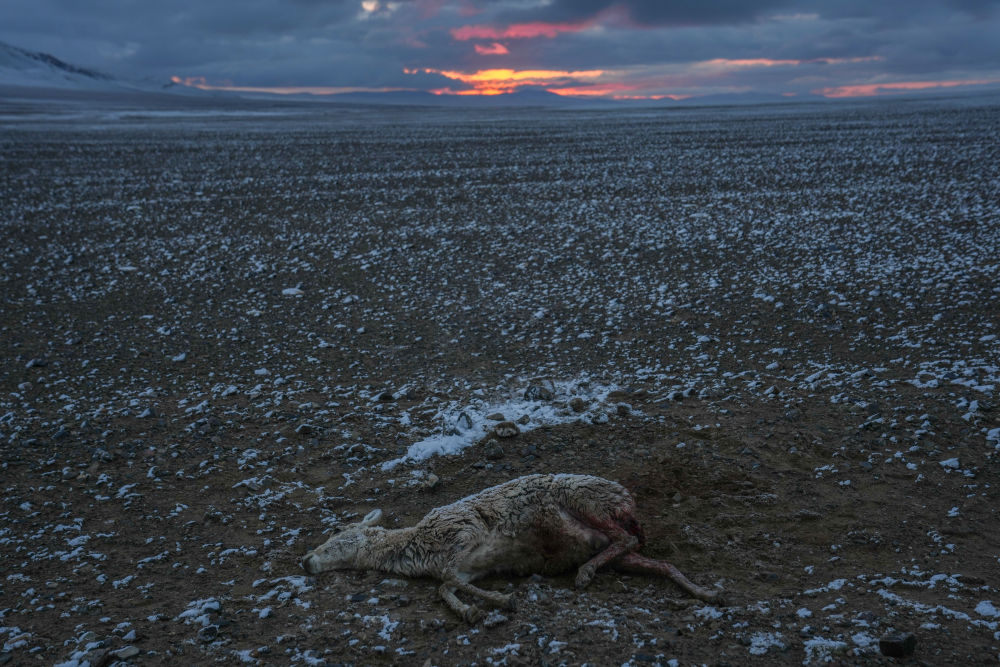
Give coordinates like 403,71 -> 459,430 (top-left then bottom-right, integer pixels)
302,474 -> 718,622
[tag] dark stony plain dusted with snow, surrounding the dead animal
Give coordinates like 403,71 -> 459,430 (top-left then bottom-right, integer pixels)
0,92 -> 1000,665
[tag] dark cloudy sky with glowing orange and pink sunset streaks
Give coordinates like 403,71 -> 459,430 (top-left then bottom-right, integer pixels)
0,0 -> 1000,98
